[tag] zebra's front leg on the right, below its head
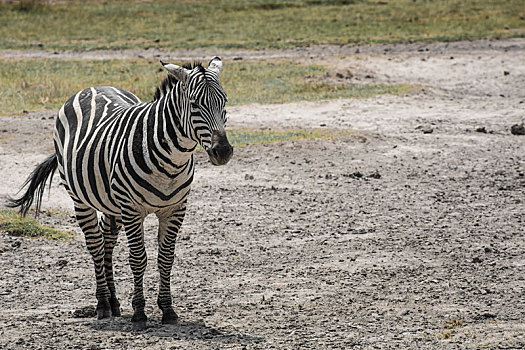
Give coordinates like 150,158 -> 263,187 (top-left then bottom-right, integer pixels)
157,203 -> 186,324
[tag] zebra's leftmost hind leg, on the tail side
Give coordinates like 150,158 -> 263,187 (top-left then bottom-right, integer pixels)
75,202 -> 111,319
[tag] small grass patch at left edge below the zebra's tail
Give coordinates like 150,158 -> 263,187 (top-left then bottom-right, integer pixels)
0,209 -> 73,241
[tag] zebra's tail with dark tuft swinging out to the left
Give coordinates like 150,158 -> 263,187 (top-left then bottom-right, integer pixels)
7,154 -> 58,216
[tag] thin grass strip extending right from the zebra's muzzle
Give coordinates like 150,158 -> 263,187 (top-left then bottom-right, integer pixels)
228,129 -> 342,147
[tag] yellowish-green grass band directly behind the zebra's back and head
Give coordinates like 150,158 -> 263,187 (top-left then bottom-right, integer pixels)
0,59 -> 414,115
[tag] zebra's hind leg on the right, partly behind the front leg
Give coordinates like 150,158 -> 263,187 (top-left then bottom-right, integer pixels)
100,214 -> 122,317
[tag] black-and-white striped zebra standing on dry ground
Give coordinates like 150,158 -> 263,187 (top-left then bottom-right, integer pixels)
9,57 -> 233,330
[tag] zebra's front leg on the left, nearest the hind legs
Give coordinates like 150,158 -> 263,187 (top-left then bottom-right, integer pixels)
122,208 -> 148,330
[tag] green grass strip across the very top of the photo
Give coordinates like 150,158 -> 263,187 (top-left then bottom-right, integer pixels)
0,0 -> 525,49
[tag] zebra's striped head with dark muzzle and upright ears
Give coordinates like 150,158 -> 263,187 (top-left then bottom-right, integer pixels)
161,57 -> 233,165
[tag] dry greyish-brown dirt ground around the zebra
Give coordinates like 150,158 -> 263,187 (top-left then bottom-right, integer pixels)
0,39 -> 525,349
